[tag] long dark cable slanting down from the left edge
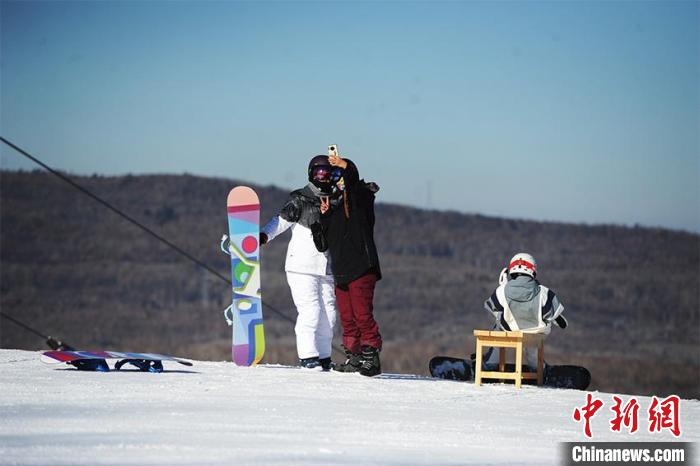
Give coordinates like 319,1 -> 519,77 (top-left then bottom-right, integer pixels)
0,136 -> 343,354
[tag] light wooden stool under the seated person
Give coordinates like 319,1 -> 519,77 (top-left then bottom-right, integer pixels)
474,330 -> 544,388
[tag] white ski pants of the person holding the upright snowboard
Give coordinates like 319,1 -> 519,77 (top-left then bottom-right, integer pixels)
287,272 -> 336,359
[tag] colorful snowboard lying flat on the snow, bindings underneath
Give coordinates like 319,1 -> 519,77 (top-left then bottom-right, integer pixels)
41,351 -> 192,372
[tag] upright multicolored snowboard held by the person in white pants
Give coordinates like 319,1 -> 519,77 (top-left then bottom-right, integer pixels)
226,186 -> 265,366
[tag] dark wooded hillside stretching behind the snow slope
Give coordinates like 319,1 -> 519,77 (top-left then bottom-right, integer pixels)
0,171 -> 700,398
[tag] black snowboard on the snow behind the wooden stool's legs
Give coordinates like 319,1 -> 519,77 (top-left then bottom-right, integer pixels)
429,356 -> 591,390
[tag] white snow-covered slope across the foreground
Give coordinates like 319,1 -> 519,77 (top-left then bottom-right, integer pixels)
0,350 -> 700,465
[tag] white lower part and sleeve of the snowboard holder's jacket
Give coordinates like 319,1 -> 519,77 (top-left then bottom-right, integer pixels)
262,215 -> 332,275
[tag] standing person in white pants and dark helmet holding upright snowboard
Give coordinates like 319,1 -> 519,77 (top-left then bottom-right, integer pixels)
260,155 -> 336,370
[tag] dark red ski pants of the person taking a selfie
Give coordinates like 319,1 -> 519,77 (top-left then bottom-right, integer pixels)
335,272 -> 382,353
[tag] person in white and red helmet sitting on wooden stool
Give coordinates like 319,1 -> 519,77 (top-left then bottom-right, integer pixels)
484,253 -> 568,370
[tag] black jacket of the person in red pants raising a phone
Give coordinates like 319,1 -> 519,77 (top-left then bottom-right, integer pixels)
316,159 -> 381,286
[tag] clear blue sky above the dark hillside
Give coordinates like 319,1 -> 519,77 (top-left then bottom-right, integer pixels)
0,1 -> 700,232
